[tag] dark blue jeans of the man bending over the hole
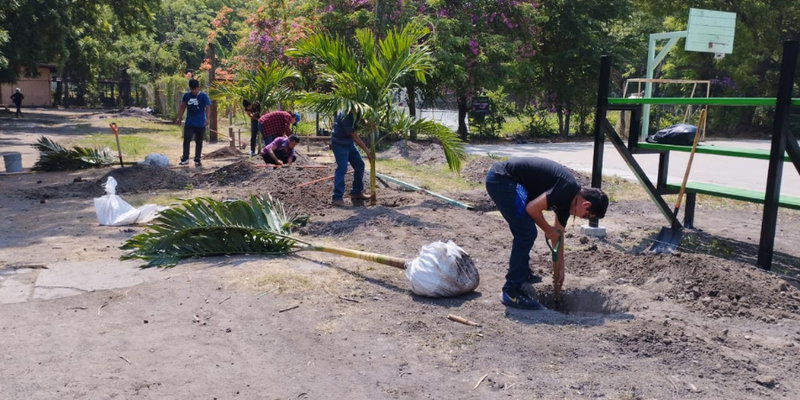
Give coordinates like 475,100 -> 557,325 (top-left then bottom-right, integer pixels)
486,169 -> 537,291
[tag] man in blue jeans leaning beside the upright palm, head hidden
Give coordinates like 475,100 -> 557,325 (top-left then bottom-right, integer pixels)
331,112 -> 372,207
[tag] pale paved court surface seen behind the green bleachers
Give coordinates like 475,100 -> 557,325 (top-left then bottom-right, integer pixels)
467,140 -> 800,197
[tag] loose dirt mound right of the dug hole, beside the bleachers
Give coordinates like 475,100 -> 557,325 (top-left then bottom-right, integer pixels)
576,249 -> 800,323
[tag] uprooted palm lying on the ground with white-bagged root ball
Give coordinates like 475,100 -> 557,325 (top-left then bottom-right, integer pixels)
121,196 -> 480,297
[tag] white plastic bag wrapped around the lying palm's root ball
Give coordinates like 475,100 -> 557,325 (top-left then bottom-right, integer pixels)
406,240 -> 481,297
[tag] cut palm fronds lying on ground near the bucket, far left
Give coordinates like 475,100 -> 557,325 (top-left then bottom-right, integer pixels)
31,136 -> 114,171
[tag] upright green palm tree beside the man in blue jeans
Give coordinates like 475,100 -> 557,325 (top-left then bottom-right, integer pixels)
286,23 -> 466,205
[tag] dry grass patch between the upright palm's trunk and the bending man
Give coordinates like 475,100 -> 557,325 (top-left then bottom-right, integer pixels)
376,157 -> 475,193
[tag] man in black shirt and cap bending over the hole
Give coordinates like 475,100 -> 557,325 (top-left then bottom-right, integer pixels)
486,157 -> 608,310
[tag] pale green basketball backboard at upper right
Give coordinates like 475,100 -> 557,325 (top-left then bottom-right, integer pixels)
685,8 -> 736,54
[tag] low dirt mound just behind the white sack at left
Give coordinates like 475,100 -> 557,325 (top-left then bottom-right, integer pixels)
98,164 -> 191,194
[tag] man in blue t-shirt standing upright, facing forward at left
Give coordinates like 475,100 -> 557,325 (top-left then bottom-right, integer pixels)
175,79 -> 211,167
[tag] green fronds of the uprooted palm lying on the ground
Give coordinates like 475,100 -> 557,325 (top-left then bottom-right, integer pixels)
121,196 -> 310,267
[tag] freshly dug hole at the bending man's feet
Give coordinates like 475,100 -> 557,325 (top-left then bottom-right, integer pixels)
536,285 -> 630,317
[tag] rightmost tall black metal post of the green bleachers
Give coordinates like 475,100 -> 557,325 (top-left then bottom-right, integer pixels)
758,40 -> 798,270
